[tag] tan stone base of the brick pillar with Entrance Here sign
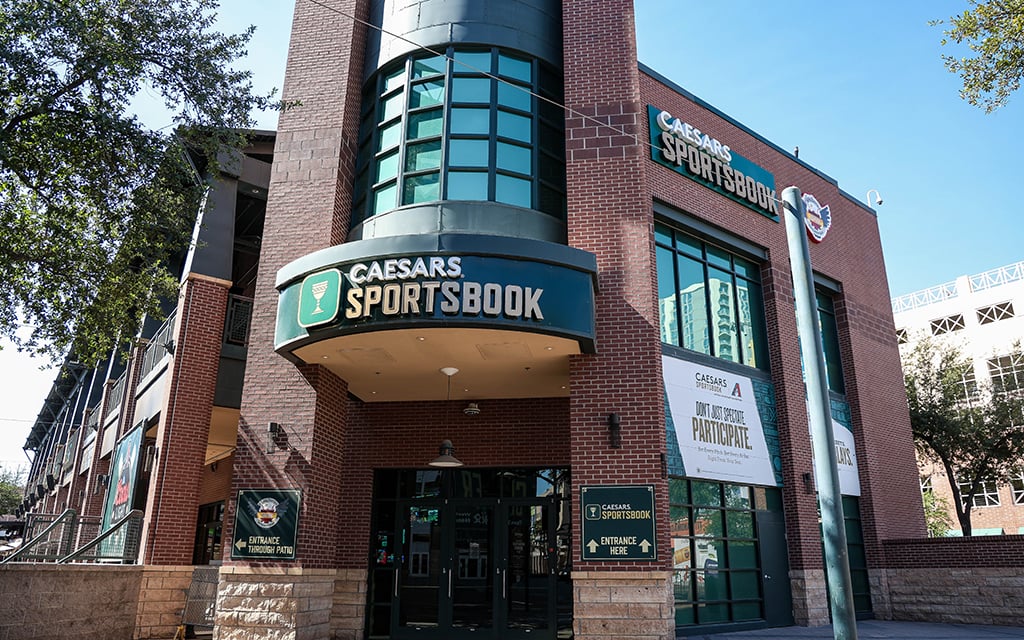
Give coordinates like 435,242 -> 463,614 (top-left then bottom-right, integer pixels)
572,571 -> 676,640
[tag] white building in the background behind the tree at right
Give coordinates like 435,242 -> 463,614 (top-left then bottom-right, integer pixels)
893,261 -> 1024,536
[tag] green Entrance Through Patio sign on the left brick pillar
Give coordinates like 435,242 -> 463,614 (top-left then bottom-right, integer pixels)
231,488 -> 302,560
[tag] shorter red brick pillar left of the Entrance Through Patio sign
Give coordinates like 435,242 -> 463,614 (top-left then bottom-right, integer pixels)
140,274 -> 230,565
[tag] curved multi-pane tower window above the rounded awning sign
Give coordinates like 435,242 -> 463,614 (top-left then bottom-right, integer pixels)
352,48 -> 565,225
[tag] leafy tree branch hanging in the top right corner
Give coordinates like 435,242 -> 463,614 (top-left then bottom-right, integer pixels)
931,0 -> 1024,114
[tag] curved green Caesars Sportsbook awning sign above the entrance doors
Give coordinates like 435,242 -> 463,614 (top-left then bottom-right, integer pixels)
275,233 -> 597,352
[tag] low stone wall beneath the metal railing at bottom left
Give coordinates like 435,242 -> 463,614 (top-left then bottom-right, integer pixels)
0,562 -> 144,640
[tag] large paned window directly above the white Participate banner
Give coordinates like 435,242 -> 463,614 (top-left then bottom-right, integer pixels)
654,224 -> 768,369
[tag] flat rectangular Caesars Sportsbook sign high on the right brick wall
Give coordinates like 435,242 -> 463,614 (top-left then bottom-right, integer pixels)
647,105 -> 778,220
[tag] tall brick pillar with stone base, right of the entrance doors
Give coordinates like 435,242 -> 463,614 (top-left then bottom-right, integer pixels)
562,0 -> 675,639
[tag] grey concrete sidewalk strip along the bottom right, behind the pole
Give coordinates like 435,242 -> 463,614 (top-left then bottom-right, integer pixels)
687,620 -> 1024,640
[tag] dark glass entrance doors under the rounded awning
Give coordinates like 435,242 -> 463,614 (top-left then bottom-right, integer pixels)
391,499 -> 559,639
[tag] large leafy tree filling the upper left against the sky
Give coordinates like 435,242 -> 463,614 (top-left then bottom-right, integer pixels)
0,0 -> 279,364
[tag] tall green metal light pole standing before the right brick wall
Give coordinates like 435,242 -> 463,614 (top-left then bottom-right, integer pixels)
782,186 -> 857,640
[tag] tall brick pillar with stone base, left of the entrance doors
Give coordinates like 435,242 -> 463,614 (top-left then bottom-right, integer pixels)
216,0 -> 370,639
